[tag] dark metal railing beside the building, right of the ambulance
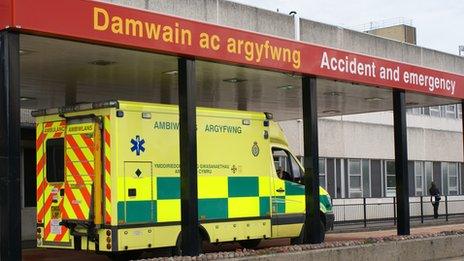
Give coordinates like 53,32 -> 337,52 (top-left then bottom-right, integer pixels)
332,196 -> 464,227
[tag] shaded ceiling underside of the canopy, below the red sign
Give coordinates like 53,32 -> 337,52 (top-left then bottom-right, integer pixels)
20,34 -> 456,120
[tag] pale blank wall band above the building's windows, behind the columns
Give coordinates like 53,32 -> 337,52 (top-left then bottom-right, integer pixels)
279,115 -> 463,162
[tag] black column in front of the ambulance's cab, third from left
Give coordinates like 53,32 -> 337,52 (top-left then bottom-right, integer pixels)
302,76 -> 324,244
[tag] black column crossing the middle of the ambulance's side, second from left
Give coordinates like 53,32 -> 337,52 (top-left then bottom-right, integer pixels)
179,58 -> 200,256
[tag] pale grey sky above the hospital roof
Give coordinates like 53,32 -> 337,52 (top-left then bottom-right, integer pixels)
236,0 -> 464,54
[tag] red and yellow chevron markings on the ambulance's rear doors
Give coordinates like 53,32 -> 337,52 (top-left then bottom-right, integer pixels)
36,115 -> 111,243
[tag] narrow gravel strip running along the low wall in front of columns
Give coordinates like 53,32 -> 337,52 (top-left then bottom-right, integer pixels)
141,229 -> 464,261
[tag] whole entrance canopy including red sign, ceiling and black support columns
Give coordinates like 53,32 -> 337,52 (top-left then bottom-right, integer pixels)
0,0 -> 464,260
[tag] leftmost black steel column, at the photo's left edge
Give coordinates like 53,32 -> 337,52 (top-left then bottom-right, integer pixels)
0,31 -> 21,261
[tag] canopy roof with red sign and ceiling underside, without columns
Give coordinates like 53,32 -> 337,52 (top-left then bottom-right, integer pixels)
4,0 -> 464,119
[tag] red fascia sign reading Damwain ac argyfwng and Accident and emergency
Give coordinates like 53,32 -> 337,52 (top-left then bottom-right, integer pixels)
5,0 -> 464,99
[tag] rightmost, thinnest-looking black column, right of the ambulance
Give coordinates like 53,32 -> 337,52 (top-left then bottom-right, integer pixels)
393,90 -> 410,235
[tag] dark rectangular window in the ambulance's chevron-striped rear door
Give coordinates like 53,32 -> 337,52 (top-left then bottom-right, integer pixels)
46,138 -> 64,183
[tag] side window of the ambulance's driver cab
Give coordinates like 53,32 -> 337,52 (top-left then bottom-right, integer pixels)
272,148 -> 303,183
